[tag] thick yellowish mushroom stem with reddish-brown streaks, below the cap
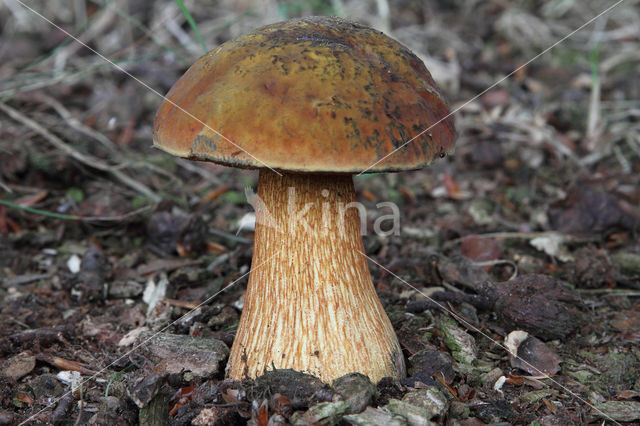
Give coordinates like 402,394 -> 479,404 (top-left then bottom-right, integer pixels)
227,170 -> 405,383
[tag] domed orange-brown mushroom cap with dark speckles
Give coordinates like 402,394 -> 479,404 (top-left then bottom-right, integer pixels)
153,17 -> 455,173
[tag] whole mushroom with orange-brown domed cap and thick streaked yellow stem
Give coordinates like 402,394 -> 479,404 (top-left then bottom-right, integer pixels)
154,17 -> 455,383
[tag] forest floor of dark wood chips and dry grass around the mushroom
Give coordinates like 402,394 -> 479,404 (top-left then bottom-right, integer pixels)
0,0 -> 640,425
